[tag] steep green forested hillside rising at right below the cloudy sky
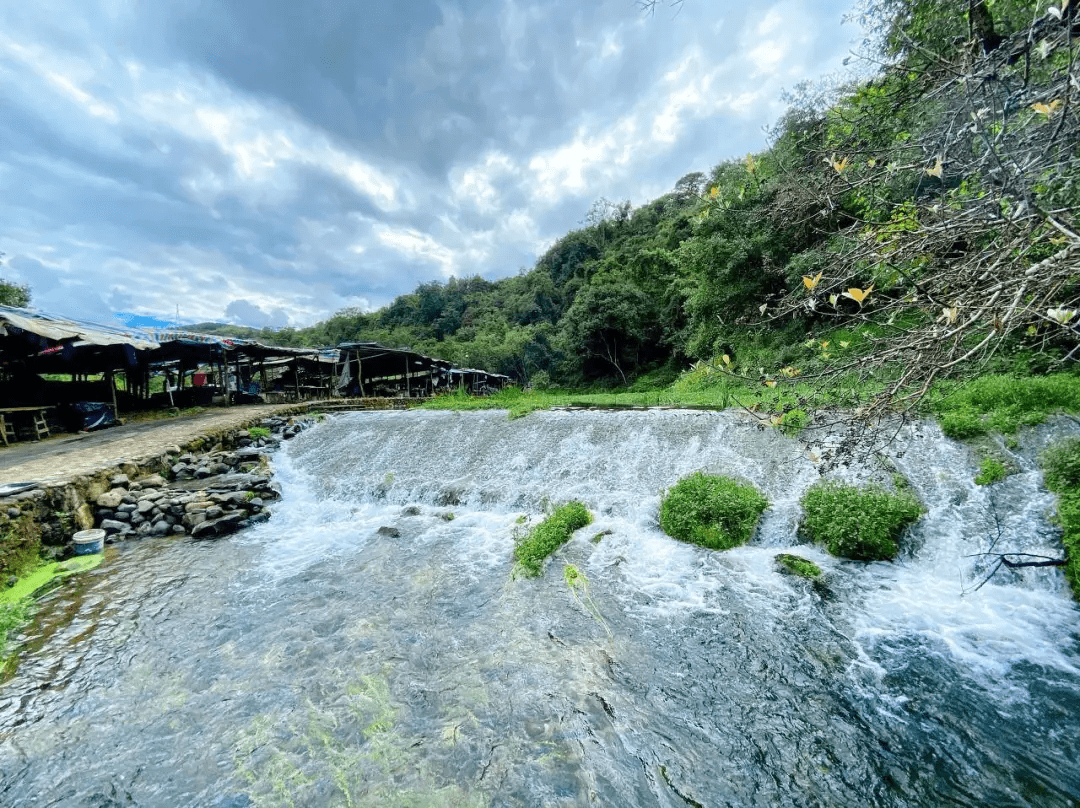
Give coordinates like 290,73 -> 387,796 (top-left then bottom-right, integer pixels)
206,0 -> 1080,393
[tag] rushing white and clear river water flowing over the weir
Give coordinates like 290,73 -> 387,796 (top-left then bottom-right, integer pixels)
0,412 -> 1080,808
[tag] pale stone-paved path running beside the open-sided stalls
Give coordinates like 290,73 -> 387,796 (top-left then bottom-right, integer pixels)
0,404 -> 295,485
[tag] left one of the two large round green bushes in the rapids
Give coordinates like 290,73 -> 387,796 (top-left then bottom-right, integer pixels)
660,471 -> 769,550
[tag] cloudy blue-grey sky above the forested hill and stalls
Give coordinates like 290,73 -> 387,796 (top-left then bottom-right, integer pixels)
0,0 -> 860,328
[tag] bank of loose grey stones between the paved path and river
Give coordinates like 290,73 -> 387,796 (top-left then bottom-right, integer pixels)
0,408 -> 311,562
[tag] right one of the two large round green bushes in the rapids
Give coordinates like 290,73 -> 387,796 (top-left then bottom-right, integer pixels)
800,482 -> 922,561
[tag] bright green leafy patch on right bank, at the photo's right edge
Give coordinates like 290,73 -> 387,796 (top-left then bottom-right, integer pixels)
930,373 -> 1080,440
